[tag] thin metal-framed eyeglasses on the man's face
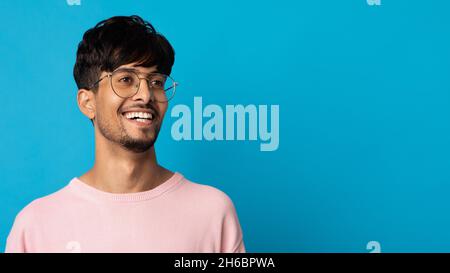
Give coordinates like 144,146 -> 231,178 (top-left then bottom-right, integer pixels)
89,68 -> 178,102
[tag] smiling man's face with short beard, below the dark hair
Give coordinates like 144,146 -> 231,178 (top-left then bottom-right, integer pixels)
94,64 -> 168,153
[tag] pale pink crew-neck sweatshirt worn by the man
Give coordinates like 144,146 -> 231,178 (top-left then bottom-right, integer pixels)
6,172 -> 245,253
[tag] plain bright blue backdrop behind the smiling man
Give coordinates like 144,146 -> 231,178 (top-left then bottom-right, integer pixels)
0,0 -> 450,252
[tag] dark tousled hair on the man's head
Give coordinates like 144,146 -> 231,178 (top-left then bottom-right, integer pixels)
73,15 -> 175,92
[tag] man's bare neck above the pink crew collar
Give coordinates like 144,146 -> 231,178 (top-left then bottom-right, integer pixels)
79,140 -> 173,193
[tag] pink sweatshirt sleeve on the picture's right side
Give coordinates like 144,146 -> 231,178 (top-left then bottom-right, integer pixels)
221,193 -> 245,253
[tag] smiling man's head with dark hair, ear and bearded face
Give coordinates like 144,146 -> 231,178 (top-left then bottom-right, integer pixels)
73,16 -> 175,152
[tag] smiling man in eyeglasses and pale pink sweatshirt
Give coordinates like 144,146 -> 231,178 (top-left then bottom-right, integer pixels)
6,16 -> 245,252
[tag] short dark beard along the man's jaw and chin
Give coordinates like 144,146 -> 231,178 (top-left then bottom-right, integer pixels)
97,111 -> 161,153
